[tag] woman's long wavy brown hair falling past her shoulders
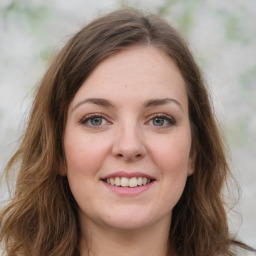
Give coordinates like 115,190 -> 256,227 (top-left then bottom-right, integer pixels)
0,9 -> 254,256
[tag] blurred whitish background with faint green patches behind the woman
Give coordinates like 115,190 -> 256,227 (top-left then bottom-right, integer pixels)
0,0 -> 256,247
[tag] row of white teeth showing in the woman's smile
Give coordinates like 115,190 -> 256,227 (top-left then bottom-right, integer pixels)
106,177 -> 150,188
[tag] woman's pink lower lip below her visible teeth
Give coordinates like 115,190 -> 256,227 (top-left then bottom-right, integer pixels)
102,181 -> 154,196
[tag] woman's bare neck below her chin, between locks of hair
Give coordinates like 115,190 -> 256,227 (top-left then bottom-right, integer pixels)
80,217 -> 174,256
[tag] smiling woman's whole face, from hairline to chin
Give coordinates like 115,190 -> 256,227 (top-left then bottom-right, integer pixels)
64,46 -> 193,230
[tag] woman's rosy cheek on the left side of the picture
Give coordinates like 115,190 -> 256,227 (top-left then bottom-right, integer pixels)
64,132 -> 106,208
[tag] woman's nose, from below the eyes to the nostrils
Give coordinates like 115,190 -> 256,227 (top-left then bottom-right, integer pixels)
112,125 -> 146,161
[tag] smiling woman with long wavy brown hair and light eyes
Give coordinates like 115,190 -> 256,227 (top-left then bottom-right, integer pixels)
0,10 -> 255,256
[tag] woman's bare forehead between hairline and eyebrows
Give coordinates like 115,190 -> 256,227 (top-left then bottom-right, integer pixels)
71,46 -> 187,111
